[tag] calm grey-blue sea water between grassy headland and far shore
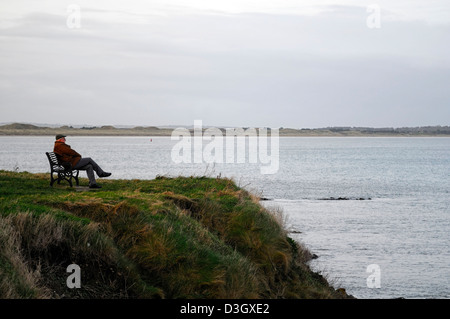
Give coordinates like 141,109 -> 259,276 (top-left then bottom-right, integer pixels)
0,136 -> 450,298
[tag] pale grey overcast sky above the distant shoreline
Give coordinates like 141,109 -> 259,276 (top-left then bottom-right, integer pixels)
0,0 -> 450,128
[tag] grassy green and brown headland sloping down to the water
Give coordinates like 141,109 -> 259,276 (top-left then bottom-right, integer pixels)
0,171 -> 352,299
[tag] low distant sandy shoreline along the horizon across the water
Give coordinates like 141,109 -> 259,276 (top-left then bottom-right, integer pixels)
0,123 -> 450,137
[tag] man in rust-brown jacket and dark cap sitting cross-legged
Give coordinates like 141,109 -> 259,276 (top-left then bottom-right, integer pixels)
53,134 -> 111,188
